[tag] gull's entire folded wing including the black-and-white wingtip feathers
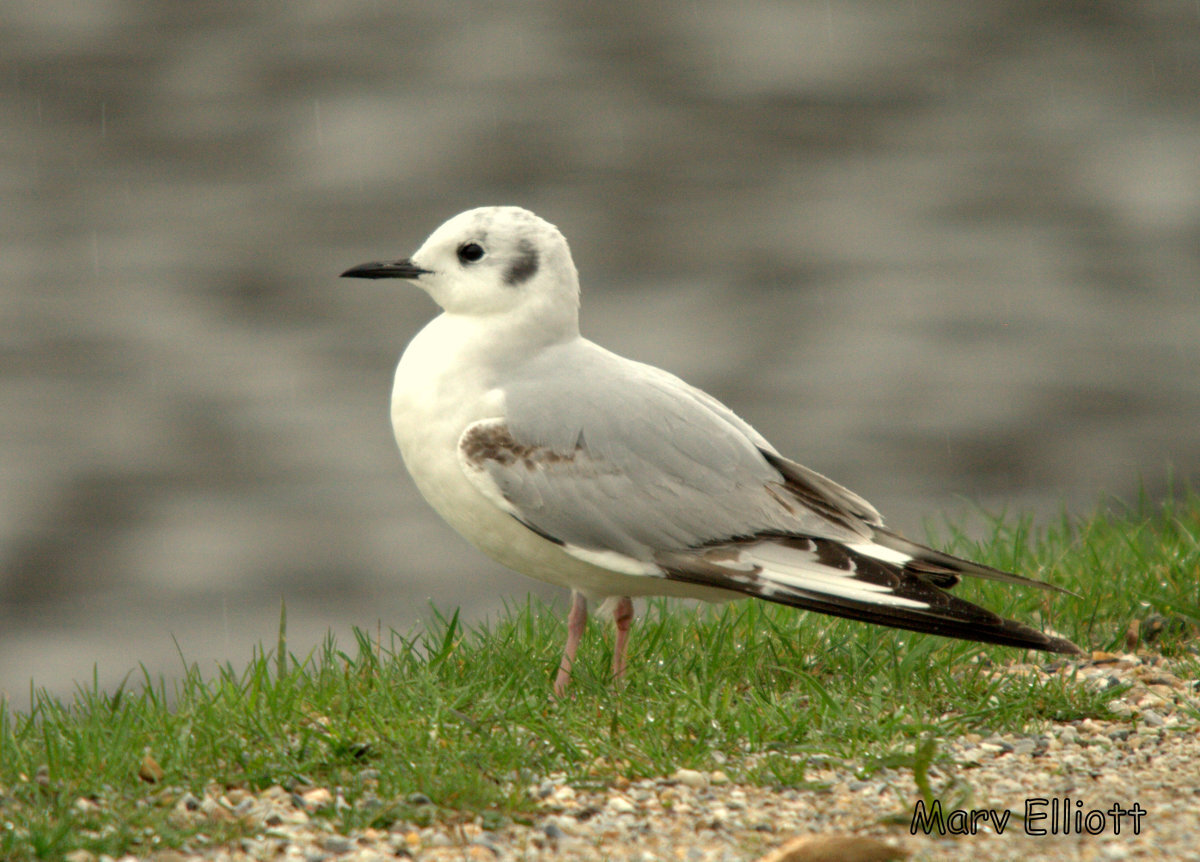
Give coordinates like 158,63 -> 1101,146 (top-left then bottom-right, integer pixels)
458,342 -> 1078,653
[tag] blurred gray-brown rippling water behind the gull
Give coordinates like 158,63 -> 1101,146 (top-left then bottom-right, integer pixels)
0,0 -> 1200,708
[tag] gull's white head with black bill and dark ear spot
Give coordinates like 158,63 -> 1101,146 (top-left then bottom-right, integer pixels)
342,206 -> 580,331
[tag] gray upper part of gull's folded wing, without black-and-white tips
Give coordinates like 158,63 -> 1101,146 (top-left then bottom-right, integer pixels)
460,340 -> 881,561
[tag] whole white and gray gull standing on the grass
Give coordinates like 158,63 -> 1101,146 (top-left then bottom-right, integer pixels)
342,206 -> 1080,696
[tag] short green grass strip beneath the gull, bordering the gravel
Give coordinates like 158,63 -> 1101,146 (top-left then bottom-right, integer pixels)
0,493 -> 1200,860
